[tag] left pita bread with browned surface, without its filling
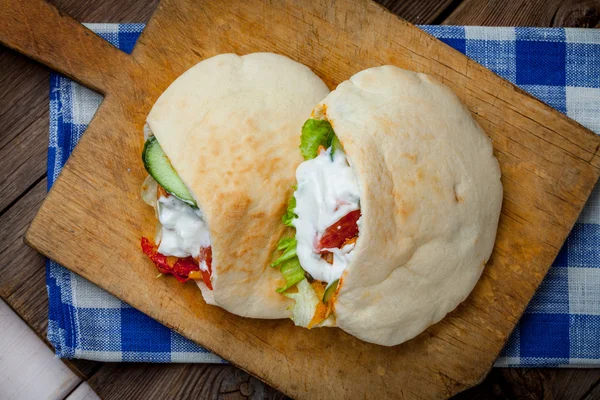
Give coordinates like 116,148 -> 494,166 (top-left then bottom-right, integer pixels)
147,53 -> 329,318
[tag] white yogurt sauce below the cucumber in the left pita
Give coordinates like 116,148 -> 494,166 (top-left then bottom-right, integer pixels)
157,196 -> 210,262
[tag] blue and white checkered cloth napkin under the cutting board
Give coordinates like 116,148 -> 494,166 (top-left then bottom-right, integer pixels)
47,24 -> 600,367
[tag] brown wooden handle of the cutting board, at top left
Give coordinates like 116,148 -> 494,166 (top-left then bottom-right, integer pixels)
0,0 -> 133,93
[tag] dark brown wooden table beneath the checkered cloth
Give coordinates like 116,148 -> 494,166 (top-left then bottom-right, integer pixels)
0,0 -> 600,399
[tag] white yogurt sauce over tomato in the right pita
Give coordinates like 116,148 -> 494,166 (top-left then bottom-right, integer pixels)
292,148 -> 360,283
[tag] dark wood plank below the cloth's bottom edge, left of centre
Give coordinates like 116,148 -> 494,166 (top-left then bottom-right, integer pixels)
88,363 -> 287,400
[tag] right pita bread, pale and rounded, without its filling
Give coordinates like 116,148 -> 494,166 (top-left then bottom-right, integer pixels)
314,66 -> 502,346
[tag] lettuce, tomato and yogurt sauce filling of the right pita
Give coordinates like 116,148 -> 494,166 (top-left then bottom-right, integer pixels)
272,119 -> 361,328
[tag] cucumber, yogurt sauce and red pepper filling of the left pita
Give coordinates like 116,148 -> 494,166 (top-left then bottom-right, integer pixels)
141,127 -> 212,290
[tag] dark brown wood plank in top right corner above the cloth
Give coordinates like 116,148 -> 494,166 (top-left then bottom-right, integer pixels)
443,0 -> 600,28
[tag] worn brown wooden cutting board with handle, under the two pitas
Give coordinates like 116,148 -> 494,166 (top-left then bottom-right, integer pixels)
0,0 -> 600,399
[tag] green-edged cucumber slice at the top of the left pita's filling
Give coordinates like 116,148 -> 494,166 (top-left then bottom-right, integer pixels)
142,136 -> 198,208
